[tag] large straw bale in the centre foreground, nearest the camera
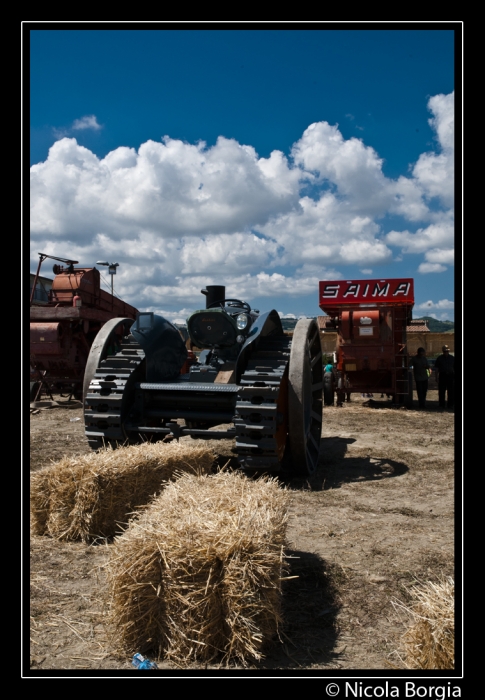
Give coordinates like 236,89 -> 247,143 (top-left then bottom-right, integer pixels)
108,471 -> 289,664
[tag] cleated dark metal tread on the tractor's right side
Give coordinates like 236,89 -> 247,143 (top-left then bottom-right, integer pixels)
234,336 -> 291,473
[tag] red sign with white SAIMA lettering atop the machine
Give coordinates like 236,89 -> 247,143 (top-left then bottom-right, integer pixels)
319,278 -> 414,309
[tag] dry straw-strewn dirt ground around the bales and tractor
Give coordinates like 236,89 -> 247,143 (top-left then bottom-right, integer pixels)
25,391 -> 461,677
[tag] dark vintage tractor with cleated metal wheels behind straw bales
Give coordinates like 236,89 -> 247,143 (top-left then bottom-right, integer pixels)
84,285 -> 322,475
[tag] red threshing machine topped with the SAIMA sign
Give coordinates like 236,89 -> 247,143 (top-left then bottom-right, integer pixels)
319,279 -> 414,405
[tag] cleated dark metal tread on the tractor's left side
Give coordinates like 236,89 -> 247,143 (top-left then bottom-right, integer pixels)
84,336 -> 145,450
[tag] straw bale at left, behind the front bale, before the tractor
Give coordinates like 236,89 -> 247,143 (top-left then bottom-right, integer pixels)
30,443 -> 214,542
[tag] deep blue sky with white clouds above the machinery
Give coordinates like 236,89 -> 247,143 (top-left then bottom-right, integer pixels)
28,23 -> 461,321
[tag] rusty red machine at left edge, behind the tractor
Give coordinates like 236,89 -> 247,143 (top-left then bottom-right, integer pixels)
30,253 -> 137,401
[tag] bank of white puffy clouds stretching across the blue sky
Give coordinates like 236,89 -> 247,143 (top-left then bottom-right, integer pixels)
31,93 -> 454,309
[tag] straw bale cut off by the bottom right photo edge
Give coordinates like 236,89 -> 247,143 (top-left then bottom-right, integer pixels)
394,578 -> 455,670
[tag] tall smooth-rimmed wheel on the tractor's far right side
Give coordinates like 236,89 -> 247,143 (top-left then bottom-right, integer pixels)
288,318 -> 323,476
